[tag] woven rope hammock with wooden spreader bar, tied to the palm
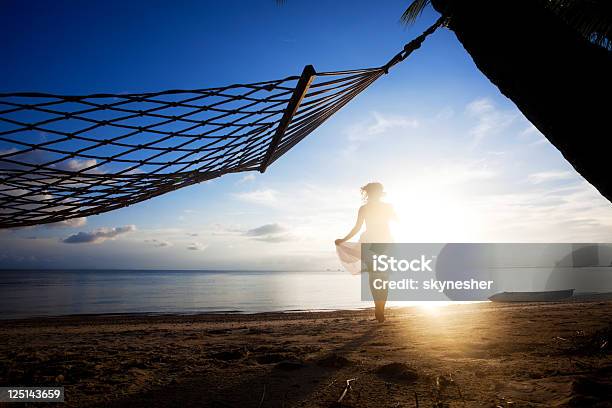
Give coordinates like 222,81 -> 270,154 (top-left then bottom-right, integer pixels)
0,19 -> 442,228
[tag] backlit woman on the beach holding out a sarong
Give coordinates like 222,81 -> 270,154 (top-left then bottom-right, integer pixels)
336,183 -> 397,323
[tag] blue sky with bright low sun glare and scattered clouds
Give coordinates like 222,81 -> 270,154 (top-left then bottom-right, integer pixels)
0,0 -> 612,270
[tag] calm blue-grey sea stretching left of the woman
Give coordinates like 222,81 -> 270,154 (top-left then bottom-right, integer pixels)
0,270 -> 370,319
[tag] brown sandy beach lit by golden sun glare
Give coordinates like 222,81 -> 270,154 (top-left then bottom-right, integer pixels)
0,301 -> 612,408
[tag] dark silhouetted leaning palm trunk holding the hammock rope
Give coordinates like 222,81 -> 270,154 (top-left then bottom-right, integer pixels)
432,0 -> 612,201
